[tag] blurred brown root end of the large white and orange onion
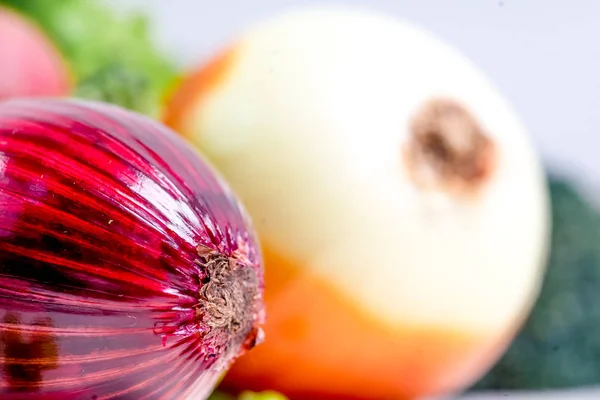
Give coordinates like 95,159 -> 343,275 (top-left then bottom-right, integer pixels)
402,98 -> 496,197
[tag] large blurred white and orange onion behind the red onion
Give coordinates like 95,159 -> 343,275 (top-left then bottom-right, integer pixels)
163,7 -> 549,399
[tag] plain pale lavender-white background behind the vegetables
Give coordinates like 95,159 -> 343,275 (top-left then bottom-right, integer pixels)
104,0 -> 600,400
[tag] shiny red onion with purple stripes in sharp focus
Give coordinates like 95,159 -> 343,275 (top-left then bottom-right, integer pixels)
0,99 -> 264,400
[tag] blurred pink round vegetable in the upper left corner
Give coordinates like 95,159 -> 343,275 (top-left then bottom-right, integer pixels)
0,7 -> 71,100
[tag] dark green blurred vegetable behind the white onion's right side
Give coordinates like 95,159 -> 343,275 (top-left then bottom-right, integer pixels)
473,178 -> 600,390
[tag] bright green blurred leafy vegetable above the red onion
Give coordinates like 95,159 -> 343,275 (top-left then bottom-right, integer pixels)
0,0 -> 177,116
